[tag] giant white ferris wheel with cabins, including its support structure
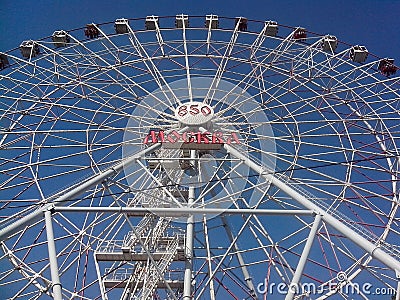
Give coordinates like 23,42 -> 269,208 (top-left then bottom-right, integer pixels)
0,14 -> 400,300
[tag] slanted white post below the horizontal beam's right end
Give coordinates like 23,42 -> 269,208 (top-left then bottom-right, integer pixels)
285,215 -> 321,300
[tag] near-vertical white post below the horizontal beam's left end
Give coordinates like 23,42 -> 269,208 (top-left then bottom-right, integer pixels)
44,208 -> 62,300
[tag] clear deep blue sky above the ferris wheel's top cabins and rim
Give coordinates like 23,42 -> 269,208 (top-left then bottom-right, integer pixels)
0,0 -> 400,61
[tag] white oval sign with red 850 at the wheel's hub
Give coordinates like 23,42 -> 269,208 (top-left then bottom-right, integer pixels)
175,102 -> 214,126
